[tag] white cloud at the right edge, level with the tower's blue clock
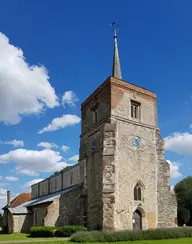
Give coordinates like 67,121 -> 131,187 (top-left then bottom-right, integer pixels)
164,132 -> 192,154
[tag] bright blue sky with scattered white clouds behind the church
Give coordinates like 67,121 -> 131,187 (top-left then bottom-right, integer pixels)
0,0 -> 192,207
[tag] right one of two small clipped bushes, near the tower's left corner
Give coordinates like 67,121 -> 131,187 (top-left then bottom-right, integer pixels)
55,225 -> 87,237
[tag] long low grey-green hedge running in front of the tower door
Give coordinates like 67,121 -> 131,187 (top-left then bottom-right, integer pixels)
71,227 -> 192,242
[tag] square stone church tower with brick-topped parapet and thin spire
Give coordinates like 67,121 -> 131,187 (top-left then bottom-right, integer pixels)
79,24 -> 177,231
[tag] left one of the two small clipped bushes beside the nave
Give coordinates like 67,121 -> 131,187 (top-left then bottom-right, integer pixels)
29,226 -> 56,237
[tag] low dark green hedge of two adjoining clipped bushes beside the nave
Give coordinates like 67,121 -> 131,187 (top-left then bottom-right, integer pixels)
29,225 -> 87,237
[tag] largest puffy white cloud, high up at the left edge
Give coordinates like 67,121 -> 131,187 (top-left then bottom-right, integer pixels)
0,32 -> 59,124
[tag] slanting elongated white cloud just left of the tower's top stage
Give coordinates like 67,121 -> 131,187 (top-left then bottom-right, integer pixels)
38,114 -> 81,134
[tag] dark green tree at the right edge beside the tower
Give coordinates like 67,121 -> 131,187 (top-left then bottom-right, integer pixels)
174,176 -> 192,226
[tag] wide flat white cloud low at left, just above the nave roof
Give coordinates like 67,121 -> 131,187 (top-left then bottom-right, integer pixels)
0,148 -> 67,175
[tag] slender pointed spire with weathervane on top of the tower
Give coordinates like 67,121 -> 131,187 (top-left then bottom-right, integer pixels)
112,22 -> 122,79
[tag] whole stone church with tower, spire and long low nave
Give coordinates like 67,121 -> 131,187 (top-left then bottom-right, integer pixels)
2,28 -> 177,233
